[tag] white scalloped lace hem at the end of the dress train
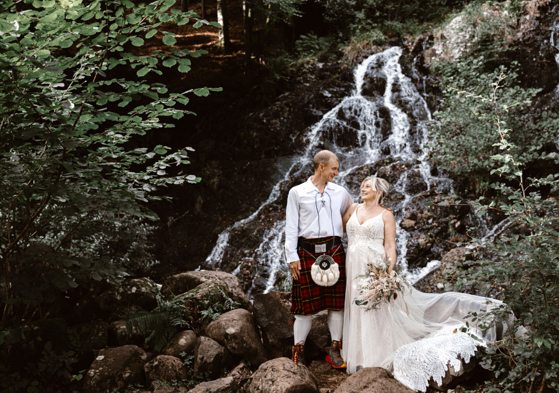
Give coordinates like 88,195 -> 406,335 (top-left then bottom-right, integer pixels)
394,330 -> 483,392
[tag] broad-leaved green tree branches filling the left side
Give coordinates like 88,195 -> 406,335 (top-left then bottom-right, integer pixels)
0,0 -> 219,332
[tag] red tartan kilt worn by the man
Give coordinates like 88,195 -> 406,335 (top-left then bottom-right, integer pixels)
291,245 -> 346,315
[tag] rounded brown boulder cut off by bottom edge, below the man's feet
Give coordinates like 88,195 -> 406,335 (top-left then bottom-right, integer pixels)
248,358 -> 318,393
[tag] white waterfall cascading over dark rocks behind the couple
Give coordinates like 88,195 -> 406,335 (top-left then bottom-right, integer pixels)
205,47 -> 480,295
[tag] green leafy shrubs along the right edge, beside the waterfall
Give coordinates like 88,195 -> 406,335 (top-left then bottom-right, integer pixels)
433,56 -> 559,392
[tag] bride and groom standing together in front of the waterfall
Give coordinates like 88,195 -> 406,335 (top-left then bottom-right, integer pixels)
285,150 -> 508,390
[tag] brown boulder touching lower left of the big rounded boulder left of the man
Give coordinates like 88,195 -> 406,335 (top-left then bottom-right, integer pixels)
194,337 -> 234,378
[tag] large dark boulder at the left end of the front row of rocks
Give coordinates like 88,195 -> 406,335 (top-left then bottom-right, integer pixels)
83,345 -> 148,393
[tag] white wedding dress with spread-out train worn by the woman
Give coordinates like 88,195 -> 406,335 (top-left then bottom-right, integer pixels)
342,209 -> 507,392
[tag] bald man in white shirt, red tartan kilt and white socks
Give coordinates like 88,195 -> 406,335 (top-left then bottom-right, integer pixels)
285,150 -> 353,368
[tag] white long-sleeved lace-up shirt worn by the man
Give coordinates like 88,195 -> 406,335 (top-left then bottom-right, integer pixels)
285,177 -> 353,263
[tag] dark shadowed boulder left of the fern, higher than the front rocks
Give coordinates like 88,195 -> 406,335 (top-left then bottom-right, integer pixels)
96,277 -> 157,312
